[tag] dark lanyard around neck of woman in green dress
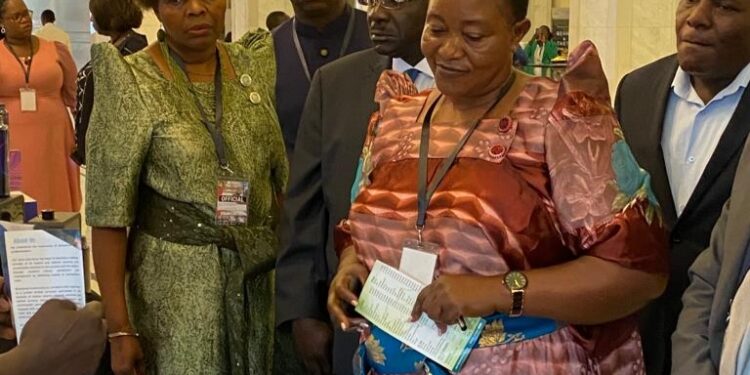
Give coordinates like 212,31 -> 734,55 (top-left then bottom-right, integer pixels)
167,46 -> 234,174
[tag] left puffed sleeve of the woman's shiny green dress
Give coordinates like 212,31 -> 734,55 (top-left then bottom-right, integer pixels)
86,43 -> 153,228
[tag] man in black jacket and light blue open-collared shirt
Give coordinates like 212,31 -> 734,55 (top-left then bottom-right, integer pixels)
615,0 -> 750,375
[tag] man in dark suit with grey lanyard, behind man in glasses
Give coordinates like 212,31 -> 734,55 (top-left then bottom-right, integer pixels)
273,0 -> 372,158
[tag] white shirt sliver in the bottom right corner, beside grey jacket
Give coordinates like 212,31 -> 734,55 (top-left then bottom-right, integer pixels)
719,273 -> 750,375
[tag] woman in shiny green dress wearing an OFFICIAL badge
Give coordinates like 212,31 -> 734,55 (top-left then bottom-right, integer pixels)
86,0 -> 288,375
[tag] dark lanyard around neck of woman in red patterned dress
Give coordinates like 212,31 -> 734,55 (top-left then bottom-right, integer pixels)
416,71 -> 516,245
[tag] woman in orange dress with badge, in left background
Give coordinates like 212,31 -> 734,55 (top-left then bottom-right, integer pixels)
0,0 -> 81,211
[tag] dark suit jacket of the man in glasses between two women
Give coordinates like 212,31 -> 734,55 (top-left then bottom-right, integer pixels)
276,49 -> 390,374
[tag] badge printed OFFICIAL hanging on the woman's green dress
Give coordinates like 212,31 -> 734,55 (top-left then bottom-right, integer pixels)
216,178 -> 250,225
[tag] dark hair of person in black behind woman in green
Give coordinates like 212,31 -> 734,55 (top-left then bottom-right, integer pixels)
89,0 -> 143,33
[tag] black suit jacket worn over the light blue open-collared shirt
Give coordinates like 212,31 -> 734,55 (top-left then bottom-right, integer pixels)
615,56 -> 750,375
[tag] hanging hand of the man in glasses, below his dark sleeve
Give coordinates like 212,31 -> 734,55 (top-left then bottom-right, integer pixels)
292,319 -> 333,375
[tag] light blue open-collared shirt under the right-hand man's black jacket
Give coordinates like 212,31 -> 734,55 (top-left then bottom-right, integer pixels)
661,64 -> 750,216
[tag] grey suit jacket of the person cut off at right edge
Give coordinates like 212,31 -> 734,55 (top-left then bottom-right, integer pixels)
672,134 -> 750,375
